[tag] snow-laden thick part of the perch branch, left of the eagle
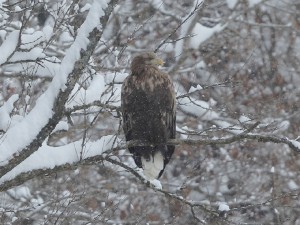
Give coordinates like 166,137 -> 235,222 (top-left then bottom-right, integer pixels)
0,135 -> 119,192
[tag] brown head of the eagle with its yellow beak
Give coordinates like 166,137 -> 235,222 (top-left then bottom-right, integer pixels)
131,52 -> 164,75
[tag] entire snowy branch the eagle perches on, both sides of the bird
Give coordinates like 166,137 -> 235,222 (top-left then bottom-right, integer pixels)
0,122 -> 300,192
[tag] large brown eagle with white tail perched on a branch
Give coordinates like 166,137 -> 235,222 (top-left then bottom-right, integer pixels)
121,52 -> 176,180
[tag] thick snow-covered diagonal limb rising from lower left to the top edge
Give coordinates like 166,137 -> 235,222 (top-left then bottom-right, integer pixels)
0,0 -> 115,177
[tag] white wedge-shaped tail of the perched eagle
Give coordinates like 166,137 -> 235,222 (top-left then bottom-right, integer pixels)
142,151 -> 164,180
